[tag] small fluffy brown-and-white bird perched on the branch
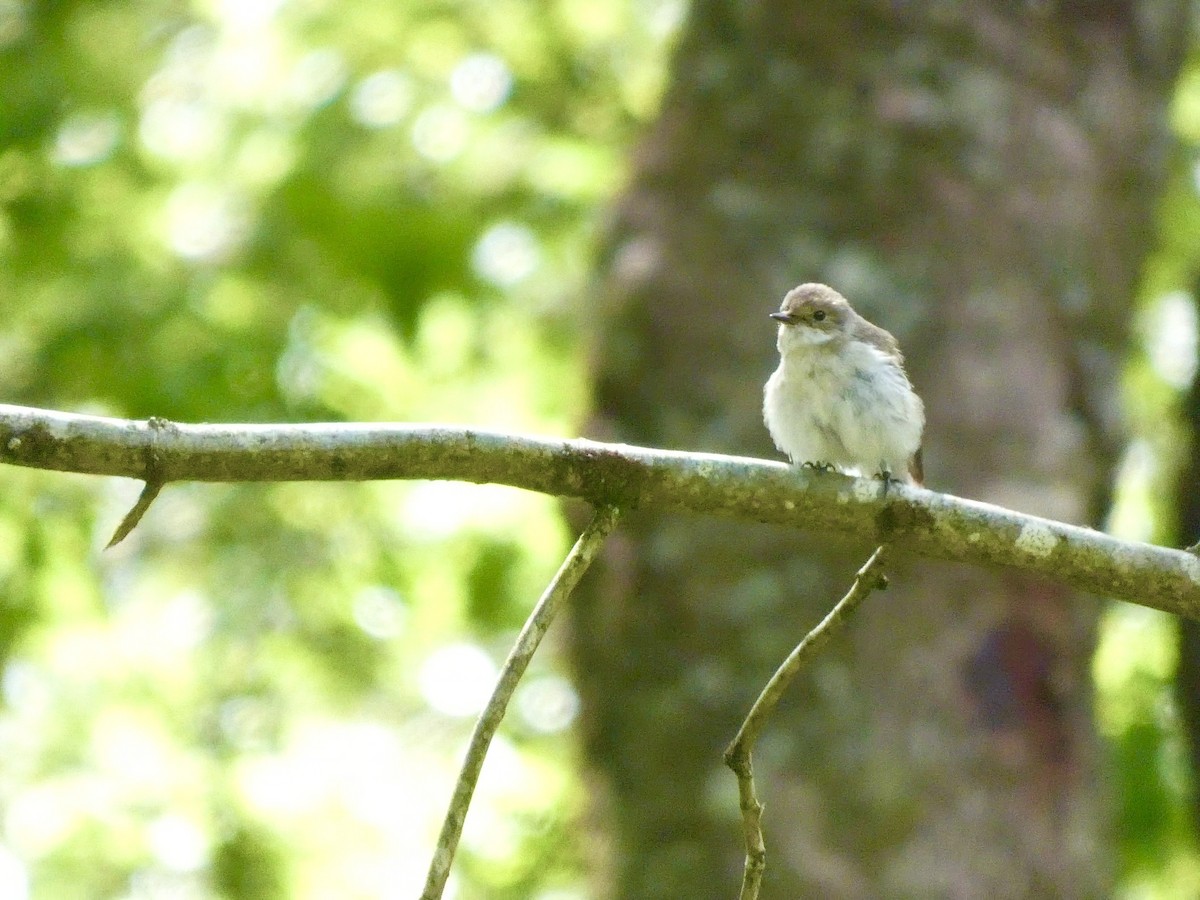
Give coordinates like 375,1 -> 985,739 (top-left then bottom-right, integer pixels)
763,282 -> 925,487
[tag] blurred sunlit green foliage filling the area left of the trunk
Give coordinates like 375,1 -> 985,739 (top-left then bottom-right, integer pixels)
0,0 -> 674,900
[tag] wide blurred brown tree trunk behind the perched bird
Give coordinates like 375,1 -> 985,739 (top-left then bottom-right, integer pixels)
572,0 -> 1187,900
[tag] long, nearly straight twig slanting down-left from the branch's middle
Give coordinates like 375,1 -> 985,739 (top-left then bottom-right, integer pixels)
421,505 -> 620,900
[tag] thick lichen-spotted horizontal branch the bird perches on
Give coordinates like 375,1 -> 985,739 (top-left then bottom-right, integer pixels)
0,406 -> 1200,619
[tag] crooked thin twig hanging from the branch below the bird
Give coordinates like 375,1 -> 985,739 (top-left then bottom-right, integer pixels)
725,547 -> 888,900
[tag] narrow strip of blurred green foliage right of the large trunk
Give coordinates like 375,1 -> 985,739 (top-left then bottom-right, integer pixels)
1093,37 -> 1200,898
